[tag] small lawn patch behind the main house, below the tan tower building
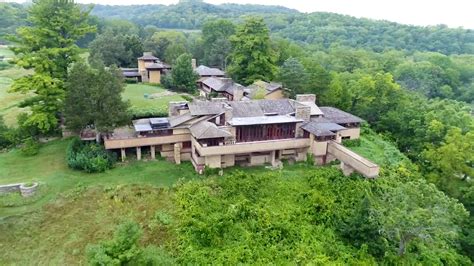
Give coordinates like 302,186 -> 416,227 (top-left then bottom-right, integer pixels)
123,84 -> 184,116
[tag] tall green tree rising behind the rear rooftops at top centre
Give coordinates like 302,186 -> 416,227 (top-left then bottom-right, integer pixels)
228,17 -> 276,85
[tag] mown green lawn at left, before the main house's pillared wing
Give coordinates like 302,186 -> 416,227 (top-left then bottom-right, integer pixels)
0,137 -> 197,219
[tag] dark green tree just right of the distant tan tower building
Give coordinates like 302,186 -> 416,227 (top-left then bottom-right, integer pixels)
166,54 -> 198,94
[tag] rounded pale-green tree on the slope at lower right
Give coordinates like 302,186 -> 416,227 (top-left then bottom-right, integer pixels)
376,180 -> 468,256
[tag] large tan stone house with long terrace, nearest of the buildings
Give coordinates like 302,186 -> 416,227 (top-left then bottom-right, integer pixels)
104,95 -> 378,177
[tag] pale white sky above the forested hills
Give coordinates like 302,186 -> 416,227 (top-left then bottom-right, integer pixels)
8,0 -> 474,29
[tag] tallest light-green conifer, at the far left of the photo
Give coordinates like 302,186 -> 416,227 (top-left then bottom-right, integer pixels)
12,0 -> 94,133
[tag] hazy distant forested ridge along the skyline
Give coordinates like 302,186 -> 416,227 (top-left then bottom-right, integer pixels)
0,1 -> 474,54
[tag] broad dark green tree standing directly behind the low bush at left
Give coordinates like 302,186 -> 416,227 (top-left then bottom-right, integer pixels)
64,63 -> 128,133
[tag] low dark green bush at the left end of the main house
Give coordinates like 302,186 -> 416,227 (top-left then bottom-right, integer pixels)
66,138 -> 117,173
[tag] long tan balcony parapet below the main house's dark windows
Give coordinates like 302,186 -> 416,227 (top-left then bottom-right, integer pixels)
192,138 -> 310,156
